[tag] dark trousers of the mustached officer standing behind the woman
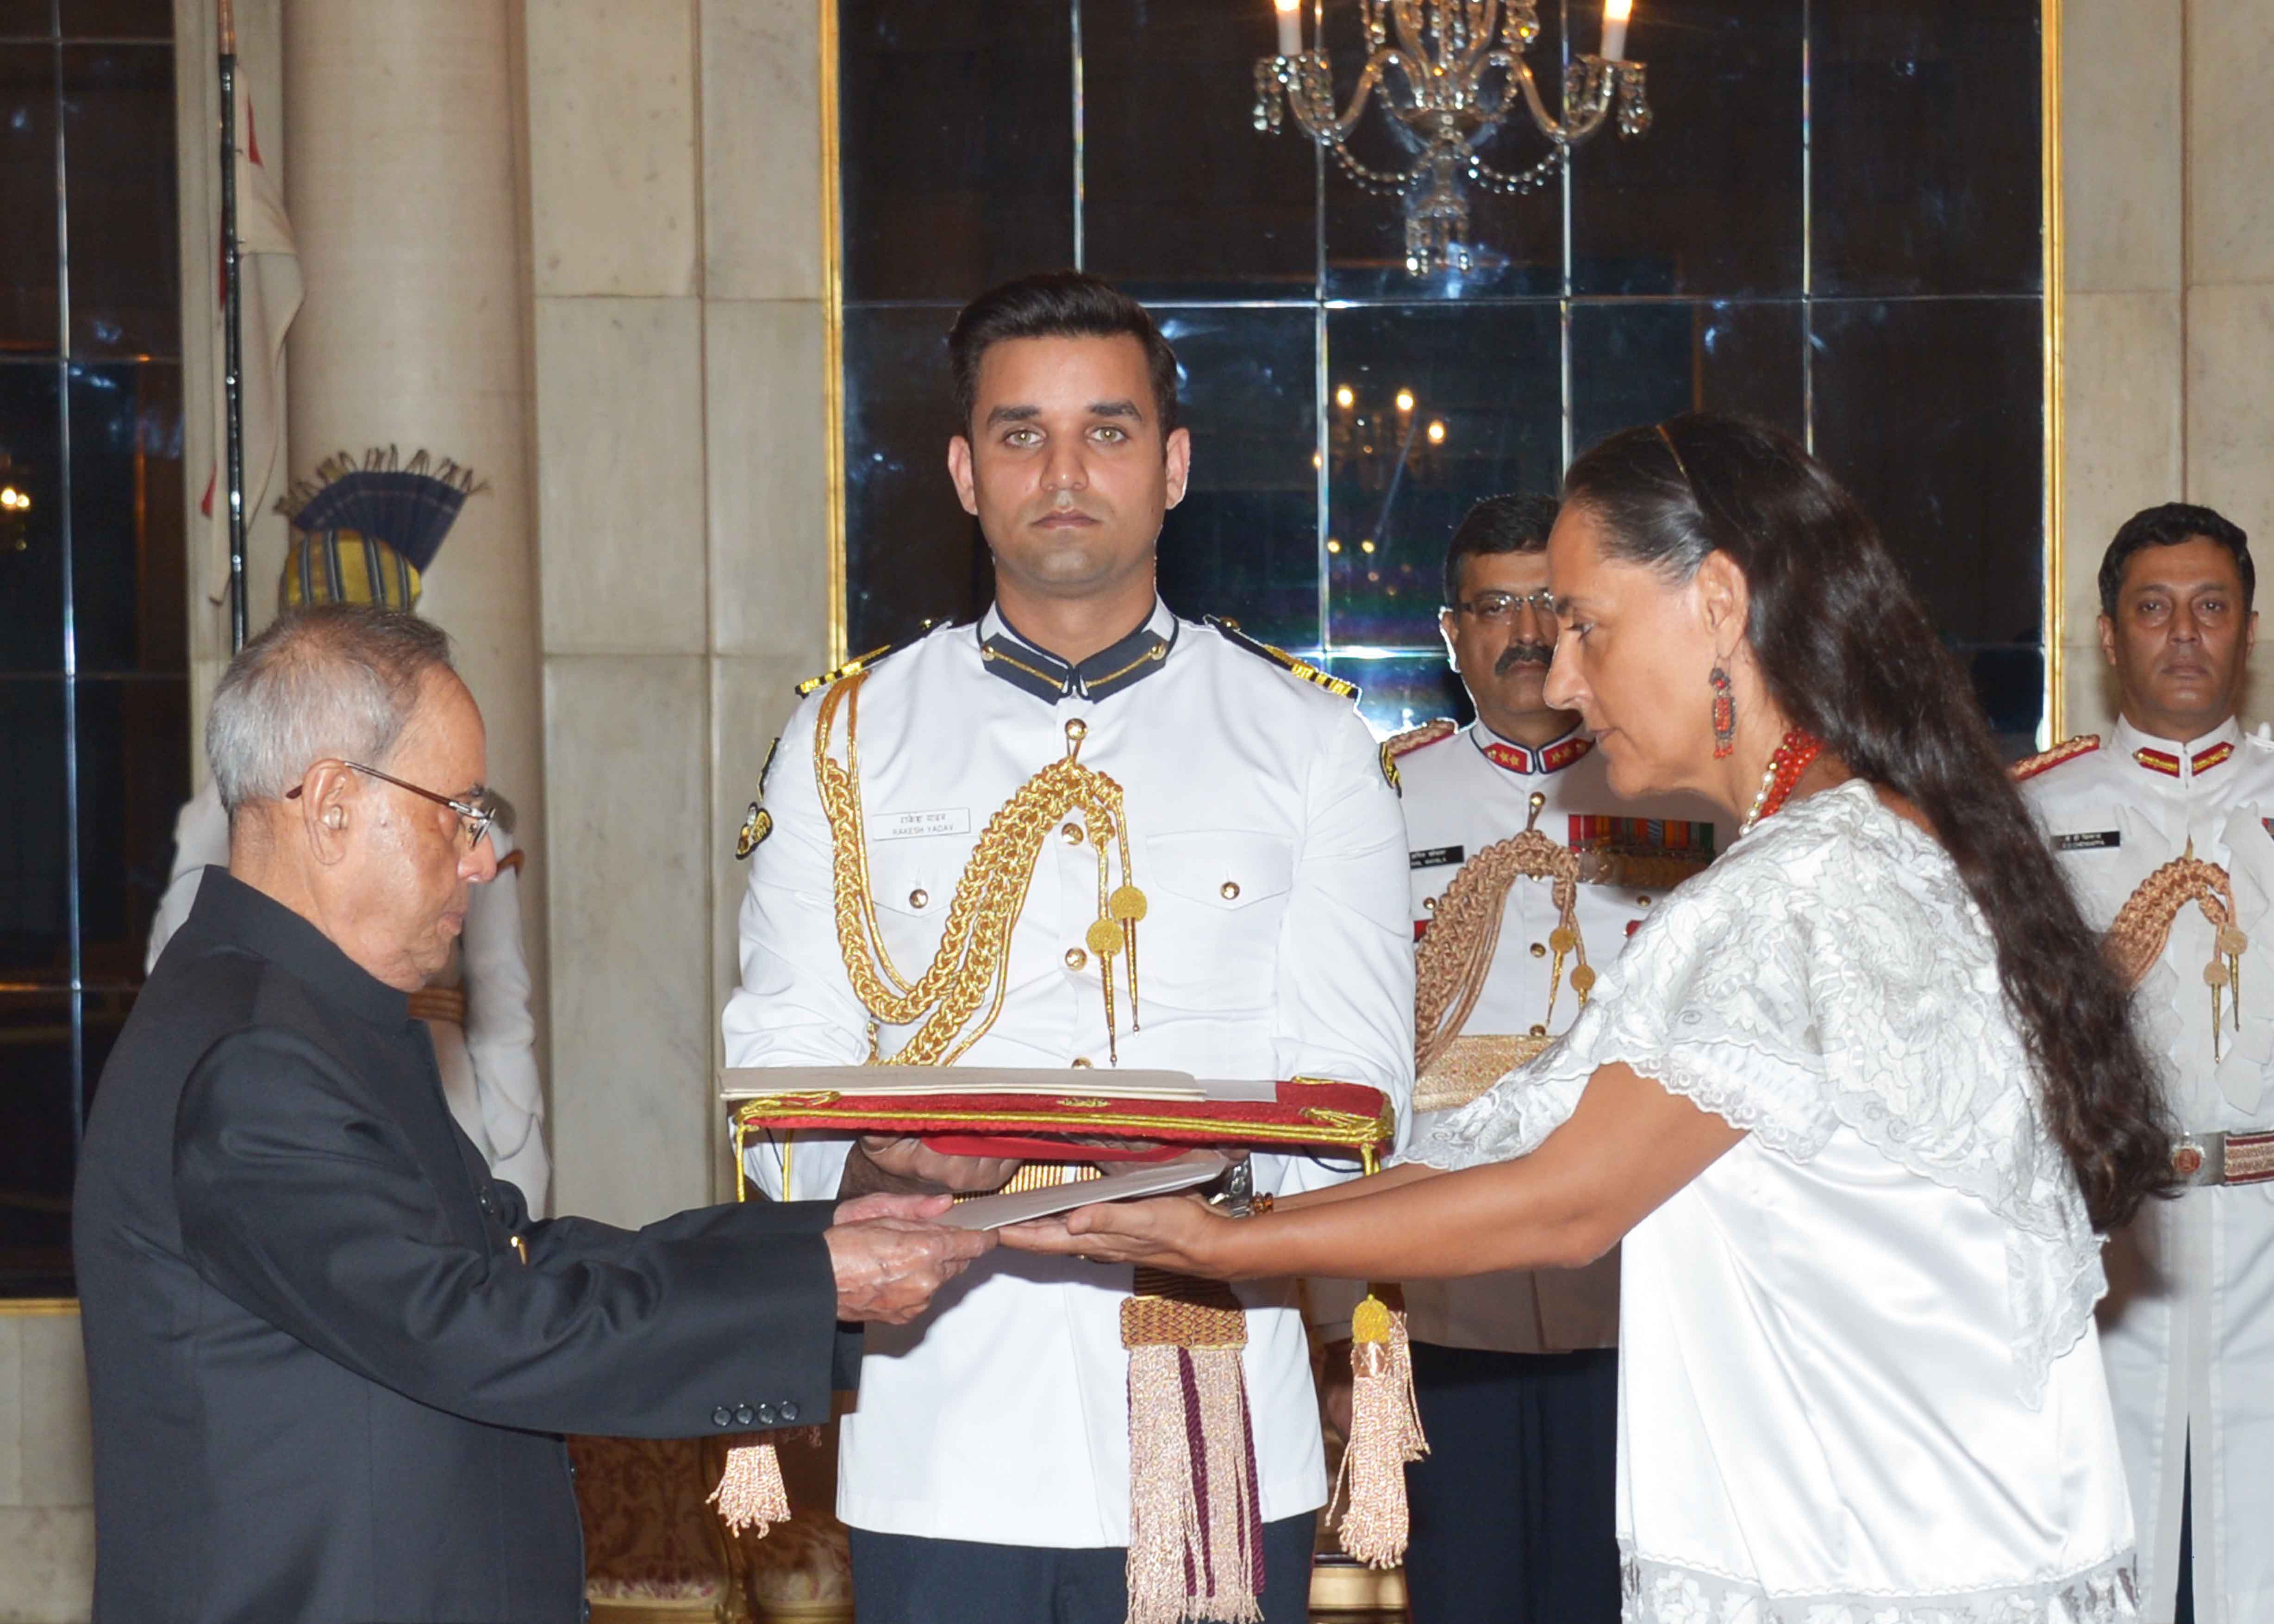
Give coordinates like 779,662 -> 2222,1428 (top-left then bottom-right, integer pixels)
1406,1342 -> 1619,1624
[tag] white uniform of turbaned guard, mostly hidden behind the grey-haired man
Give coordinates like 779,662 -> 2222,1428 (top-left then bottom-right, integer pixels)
143,780 -> 553,1217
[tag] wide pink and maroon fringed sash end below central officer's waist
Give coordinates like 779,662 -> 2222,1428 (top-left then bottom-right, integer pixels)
1121,1271 -> 1264,1624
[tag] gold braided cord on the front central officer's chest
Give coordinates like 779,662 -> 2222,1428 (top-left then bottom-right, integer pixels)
814,673 -> 1146,1067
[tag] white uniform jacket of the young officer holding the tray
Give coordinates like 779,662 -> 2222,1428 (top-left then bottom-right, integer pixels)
725,605 -> 1412,1549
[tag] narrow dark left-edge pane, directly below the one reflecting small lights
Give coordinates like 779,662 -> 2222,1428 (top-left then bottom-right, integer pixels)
0,678 -> 70,987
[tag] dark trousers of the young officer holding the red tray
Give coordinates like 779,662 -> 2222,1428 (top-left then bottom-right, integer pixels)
850,1512 -> 1319,1624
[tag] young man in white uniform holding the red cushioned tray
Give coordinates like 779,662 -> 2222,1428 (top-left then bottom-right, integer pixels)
725,273 -> 1412,1624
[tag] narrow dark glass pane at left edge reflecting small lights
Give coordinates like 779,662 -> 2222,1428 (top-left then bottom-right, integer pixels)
0,361 -> 64,671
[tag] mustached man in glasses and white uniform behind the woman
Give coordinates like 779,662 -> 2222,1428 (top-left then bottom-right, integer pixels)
1389,496 -> 1730,1624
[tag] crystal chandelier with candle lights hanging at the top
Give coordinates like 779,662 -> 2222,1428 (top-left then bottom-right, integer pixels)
1255,0 -> 1651,275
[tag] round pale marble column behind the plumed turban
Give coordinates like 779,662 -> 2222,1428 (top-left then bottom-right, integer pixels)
284,0 -> 548,1064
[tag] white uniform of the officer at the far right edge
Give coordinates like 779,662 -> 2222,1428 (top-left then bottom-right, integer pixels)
2022,721 -> 2274,1624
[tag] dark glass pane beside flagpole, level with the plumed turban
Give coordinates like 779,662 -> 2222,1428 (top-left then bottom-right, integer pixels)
70,361 -> 189,673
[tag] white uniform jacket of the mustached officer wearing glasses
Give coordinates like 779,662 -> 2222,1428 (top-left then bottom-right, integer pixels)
1396,721 -> 1735,1353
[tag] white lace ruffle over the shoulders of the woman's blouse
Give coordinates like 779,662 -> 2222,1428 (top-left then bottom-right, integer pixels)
1406,783 -> 2106,1401
